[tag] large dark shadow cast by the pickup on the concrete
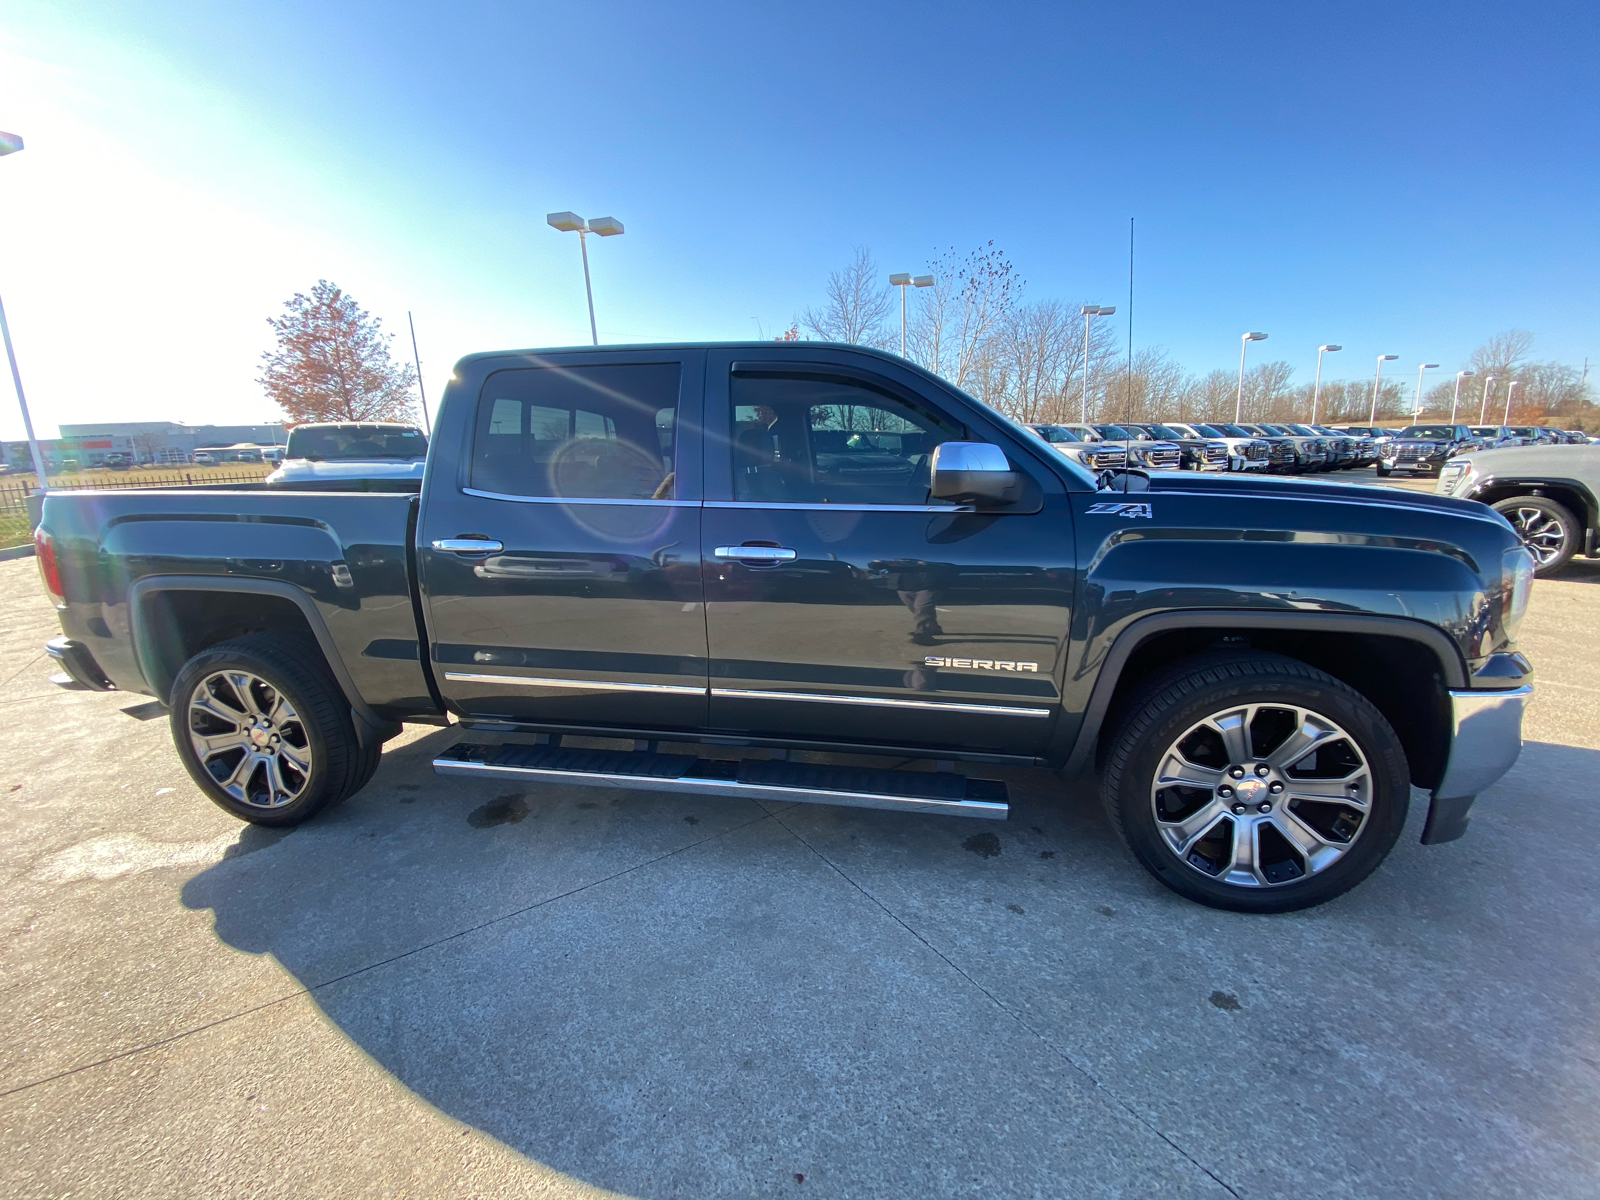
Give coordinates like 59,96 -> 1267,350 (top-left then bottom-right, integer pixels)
182,731 -> 1600,1197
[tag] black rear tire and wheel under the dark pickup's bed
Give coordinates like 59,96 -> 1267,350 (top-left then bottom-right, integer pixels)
171,634 -> 366,826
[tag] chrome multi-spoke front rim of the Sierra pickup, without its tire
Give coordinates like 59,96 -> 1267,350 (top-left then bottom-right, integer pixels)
1150,704 -> 1373,888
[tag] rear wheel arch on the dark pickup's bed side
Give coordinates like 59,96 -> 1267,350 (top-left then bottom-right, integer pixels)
128,576 -> 400,742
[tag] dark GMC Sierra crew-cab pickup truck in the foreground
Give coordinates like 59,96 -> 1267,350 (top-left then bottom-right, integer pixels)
37,342 -> 1533,912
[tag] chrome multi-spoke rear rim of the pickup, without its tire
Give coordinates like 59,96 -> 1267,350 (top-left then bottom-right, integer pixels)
189,670 -> 312,808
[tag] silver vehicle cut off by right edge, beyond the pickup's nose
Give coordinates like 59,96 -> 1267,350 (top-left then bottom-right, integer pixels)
1434,445 -> 1600,574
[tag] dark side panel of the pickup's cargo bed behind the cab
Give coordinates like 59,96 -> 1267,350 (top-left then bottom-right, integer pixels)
43,488 -> 438,720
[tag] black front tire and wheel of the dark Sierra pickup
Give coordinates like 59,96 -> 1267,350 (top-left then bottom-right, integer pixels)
1102,653 -> 1411,912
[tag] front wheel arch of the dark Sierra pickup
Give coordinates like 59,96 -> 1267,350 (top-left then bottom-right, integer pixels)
1062,610 -> 1467,789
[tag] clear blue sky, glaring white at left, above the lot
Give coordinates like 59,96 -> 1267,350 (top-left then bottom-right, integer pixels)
0,0 -> 1600,435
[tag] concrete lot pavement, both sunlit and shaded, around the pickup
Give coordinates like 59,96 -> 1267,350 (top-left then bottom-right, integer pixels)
0,482 -> 1600,1198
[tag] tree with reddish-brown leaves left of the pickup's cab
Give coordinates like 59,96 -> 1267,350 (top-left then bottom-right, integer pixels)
256,278 -> 416,424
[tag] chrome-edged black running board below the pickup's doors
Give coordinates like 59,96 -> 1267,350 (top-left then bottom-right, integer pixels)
434,742 -> 1010,821
